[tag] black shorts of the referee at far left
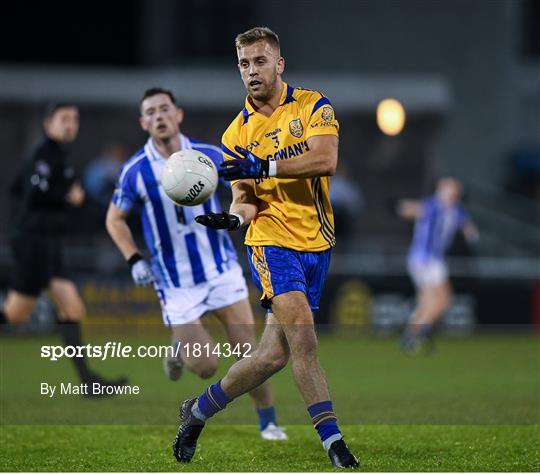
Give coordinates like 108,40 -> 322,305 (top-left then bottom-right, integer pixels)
11,233 -> 67,296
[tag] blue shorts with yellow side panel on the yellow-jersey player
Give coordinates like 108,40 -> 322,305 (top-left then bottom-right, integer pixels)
247,245 -> 332,311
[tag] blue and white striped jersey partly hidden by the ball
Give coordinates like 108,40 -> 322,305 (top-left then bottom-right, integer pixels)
112,135 -> 237,288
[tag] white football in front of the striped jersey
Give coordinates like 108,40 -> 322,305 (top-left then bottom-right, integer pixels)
161,150 -> 219,206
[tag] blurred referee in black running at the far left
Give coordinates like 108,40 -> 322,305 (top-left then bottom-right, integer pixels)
0,103 -> 126,392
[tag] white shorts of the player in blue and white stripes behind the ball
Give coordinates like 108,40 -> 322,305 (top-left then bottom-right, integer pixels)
157,263 -> 248,326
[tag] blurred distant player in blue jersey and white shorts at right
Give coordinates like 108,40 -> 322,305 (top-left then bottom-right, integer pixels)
397,177 -> 478,352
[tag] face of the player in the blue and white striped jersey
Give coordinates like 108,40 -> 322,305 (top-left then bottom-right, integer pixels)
139,94 -> 184,140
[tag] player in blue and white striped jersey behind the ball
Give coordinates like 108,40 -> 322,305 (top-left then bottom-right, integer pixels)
107,88 -> 286,440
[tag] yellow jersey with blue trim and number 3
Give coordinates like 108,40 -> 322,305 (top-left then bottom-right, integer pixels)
222,83 -> 339,252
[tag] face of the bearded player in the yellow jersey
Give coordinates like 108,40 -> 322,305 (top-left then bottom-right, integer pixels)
237,40 -> 285,102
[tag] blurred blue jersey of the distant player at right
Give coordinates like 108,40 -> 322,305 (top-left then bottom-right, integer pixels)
409,196 -> 468,262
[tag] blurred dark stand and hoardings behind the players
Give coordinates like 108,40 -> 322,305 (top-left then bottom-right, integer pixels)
0,0 -> 540,327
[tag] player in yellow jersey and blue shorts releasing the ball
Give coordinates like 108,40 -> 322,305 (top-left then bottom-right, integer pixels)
173,28 -> 358,467
